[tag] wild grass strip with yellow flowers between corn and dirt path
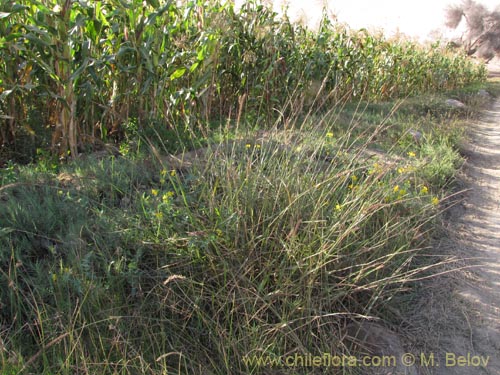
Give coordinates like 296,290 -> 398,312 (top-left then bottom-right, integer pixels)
0,81 -> 496,375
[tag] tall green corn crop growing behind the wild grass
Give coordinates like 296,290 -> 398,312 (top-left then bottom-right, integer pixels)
0,0 -> 485,157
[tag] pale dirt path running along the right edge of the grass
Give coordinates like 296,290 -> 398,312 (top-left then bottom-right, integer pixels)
415,94 -> 500,375
